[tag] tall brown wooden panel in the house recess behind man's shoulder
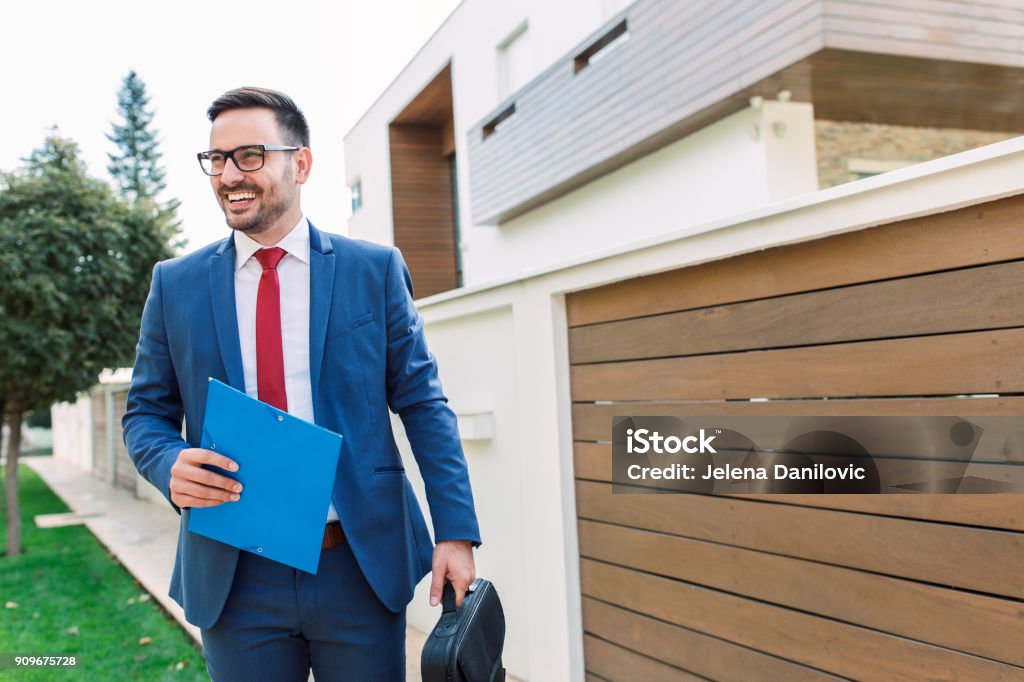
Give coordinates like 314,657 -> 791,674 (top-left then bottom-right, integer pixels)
389,124 -> 458,297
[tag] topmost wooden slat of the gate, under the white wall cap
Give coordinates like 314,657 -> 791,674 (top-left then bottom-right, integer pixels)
565,196 -> 1024,327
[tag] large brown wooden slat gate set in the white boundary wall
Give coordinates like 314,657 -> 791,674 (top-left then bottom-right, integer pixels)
566,191 -> 1024,680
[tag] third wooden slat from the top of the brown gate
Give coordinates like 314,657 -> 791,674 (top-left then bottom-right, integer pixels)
571,327 -> 1024,400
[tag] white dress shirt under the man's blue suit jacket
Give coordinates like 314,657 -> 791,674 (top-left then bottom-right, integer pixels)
234,216 -> 338,522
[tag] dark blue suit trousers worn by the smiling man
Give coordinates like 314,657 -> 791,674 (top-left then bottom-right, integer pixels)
202,543 -> 406,682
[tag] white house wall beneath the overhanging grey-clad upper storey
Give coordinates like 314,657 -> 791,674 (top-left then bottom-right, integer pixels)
463,101 -> 817,285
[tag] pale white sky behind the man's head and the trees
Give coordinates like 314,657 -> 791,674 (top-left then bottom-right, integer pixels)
0,0 -> 459,251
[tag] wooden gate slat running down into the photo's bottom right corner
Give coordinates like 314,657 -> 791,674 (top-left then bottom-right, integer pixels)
580,559 -> 1024,682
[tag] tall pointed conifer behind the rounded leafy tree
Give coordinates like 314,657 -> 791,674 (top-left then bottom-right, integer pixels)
106,71 -> 180,231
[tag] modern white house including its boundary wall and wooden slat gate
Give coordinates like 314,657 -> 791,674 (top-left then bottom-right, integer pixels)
345,0 -> 1024,680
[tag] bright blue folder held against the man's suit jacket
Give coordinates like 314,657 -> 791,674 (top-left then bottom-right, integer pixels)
188,379 -> 341,573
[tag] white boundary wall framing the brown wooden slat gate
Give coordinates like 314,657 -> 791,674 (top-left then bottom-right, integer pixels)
395,137 -> 1024,682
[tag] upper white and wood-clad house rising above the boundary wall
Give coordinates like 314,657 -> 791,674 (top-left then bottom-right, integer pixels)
345,0 -> 1024,296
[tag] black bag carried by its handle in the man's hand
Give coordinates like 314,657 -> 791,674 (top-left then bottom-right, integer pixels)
420,578 -> 505,682
